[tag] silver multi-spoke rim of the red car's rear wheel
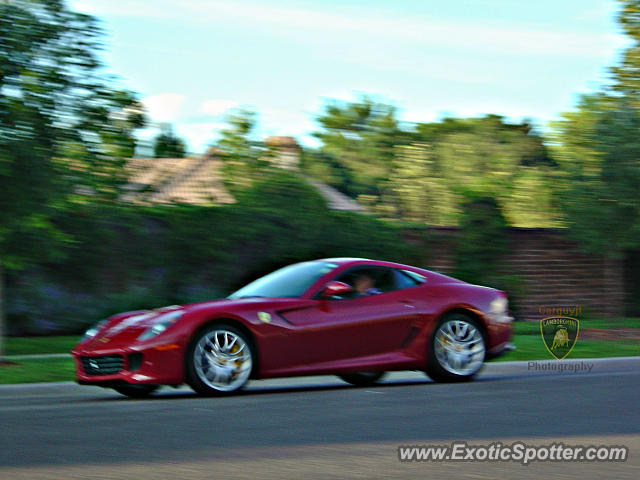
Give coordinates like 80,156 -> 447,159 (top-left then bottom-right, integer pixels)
433,319 -> 485,376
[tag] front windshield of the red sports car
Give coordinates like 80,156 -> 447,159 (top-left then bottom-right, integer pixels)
227,262 -> 338,298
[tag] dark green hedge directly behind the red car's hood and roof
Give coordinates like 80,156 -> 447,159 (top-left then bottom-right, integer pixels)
7,171 -> 418,334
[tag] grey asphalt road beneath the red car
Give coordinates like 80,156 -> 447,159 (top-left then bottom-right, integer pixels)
0,357 -> 640,480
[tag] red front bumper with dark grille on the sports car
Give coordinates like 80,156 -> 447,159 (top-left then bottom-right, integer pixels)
71,344 -> 184,386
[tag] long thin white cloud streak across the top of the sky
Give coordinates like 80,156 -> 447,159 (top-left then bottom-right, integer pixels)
74,0 -> 624,57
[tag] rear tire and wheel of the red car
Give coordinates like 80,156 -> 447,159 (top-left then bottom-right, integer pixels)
426,313 -> 487,382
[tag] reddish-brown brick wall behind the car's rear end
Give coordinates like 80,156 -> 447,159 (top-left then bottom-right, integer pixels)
407,227 -> 624,320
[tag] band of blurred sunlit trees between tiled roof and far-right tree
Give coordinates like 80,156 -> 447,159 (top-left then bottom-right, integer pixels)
310,103 -> 557,226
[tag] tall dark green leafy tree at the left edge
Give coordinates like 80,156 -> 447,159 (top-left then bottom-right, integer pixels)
0,0 -> 144,355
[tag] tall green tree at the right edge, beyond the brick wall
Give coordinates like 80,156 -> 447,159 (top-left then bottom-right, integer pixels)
552,0 -> 640,257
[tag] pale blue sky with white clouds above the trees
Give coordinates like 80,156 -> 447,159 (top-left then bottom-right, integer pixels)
70,0 -> 626,153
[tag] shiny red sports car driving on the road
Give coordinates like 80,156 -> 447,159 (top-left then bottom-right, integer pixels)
72,258 -> 512,396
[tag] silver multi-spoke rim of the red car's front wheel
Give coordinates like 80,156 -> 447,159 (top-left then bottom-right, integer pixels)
193,327 -> 252,392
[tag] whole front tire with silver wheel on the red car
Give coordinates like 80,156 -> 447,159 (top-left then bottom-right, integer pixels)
185,324 -> 256,395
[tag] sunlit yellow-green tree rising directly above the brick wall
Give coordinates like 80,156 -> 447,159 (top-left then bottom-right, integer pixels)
384,115 -> 556,226
